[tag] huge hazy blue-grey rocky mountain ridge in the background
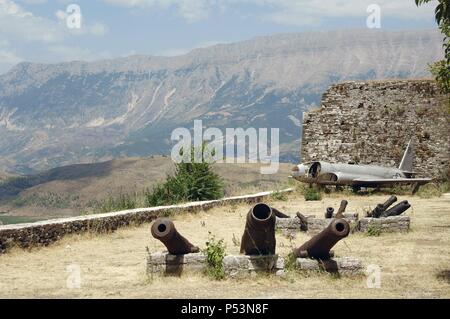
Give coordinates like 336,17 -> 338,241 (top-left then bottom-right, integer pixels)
0,30 -> 442,173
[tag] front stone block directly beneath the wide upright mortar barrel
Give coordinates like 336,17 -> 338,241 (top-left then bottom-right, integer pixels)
223,255 -> 284,277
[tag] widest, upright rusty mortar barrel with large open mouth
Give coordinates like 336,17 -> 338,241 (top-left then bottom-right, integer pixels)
241,203 -> 276,255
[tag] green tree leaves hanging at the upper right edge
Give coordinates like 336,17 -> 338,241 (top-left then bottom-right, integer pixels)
415,0 -> 450,93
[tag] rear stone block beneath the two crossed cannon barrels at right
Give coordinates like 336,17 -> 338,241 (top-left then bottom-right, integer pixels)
358,216 -> 411,233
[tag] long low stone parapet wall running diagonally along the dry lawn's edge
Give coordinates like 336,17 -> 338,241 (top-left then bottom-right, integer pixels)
0,189 -> 292,253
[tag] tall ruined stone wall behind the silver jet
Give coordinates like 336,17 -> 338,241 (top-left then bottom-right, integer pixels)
301,80 -> 450,177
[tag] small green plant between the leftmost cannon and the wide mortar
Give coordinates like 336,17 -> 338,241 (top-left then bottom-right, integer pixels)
203,232 -> 226,280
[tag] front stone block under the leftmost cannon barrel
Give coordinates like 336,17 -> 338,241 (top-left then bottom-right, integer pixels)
147,252 -> 206,276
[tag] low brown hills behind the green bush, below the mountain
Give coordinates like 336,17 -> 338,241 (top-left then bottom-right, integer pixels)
0,156 -> 291,216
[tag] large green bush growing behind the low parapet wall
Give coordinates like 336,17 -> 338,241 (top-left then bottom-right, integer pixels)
145,147 -> 224,206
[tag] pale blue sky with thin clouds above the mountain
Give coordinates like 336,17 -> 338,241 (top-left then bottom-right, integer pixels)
0,0 -> 436,73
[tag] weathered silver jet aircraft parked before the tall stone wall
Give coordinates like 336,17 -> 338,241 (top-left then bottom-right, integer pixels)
292,140 -> 432,192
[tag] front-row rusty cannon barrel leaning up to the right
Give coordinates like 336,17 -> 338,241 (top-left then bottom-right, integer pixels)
293,218 -> 350,260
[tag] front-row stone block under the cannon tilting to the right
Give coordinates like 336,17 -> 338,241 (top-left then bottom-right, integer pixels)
295,257 -> 363,276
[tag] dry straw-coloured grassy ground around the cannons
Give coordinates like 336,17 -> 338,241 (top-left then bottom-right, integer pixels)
0,194 -> 450,298
